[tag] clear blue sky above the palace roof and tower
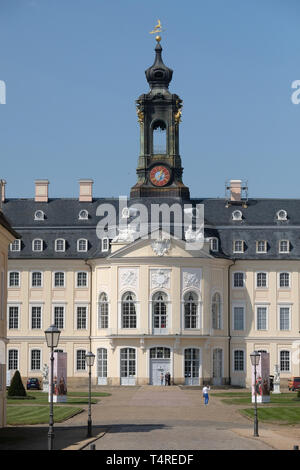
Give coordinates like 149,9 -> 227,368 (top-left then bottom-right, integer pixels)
0,0 -> 300,198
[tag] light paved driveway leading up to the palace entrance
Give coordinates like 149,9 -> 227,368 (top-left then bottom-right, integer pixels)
0,386 -> 300,451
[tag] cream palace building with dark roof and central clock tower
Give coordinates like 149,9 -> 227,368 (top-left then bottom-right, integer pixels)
3,38 -> 300,386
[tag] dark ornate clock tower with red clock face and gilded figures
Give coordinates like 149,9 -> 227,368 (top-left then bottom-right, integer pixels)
130,36 -> 190,200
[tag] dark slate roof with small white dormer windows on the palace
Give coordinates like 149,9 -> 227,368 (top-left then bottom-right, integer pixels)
3,198 -> 300,259
